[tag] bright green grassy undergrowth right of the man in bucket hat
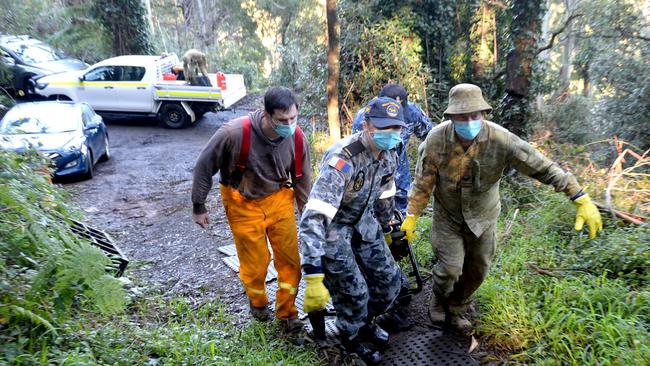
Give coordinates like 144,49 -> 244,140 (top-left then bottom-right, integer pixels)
470,184 -> 650,365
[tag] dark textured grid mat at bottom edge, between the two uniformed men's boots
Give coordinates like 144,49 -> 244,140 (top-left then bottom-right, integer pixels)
381,330 -> 478,366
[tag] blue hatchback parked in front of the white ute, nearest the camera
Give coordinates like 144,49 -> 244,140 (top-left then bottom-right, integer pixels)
0,101 -> 111,179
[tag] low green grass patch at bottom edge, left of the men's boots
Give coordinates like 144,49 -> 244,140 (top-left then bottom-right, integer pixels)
77,294 -> 318,365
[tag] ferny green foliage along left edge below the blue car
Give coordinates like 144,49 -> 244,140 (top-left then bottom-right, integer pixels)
0,151 -> 125,362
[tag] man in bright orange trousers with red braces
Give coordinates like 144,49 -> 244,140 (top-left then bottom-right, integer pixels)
192,88 -> 311,334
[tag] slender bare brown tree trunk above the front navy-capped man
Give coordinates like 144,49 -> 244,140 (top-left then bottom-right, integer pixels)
326,0 -> 341,141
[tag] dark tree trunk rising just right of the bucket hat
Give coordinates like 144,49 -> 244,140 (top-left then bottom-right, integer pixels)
498,0 -> 543,136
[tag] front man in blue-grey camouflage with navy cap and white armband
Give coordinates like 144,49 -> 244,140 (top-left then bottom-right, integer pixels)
299,97 -> 405,363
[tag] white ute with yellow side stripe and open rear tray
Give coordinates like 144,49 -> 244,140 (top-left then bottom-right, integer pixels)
33,54 -> 246,128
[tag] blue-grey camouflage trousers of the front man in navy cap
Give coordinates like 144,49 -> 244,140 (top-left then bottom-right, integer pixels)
322,231 -> 402,338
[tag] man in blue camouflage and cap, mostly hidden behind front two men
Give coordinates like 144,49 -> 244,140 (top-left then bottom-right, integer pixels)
352,84 -> 432,217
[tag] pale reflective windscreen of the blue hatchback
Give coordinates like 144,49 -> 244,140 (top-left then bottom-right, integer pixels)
0,104 -> 81,135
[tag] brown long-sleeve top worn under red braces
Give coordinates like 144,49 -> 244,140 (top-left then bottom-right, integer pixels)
192,110 -> 311,214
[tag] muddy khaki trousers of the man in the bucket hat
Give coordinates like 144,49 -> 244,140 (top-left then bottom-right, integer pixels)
431,209 -> 496,314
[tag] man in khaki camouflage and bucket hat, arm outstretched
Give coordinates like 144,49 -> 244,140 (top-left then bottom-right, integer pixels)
402,84 -> 602,330
